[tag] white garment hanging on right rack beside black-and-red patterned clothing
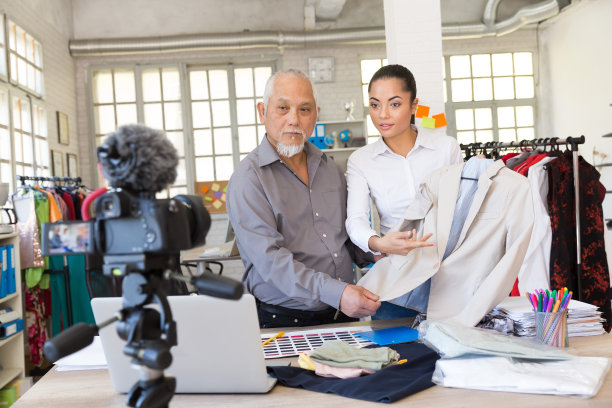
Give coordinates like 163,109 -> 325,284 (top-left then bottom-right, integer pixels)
518,157 -> 556,295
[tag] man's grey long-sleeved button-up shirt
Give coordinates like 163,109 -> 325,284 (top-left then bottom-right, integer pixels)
226,137 -> 353,310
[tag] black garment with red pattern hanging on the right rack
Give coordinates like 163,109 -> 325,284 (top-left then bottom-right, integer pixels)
547,151 -> 612,332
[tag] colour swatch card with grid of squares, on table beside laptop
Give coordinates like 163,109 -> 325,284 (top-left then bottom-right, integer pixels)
261,326 -> 374,358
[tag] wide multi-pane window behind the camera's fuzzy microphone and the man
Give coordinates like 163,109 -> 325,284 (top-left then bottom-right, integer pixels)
92,64 -> 272,196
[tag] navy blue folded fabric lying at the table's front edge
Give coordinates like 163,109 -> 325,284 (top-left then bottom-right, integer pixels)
268,343 -> 440,403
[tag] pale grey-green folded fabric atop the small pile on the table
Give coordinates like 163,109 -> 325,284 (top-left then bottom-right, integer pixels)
308,340 -> 399,370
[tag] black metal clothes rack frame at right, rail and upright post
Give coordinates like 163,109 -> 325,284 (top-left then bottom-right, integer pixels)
460,135 -> 585,300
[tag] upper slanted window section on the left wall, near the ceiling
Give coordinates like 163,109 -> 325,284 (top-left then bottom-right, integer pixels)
7,20 -> 44,95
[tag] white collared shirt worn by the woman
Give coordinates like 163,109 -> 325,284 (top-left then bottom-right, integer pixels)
346,128 -> 463,252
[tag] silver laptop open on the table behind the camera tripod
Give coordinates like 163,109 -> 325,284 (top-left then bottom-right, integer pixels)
91,294 -> 276,393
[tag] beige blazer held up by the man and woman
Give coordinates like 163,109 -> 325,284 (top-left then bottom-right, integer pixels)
358,160 -> 533,326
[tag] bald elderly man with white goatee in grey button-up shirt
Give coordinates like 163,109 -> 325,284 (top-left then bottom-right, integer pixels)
227,70 -> 380,327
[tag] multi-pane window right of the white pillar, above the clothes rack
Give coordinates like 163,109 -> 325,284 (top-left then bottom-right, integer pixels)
444,52 -> 536,143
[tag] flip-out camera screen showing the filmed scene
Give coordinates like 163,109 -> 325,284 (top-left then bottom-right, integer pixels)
42,221 -> 94,256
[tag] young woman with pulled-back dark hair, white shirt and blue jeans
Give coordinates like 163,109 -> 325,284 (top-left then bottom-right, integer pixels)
346,65 -> 462,319
